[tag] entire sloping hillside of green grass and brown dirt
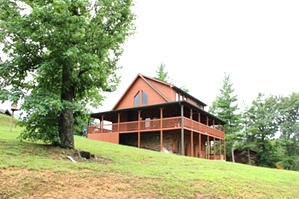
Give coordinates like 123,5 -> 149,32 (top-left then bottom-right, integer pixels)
0,115 -> 299,198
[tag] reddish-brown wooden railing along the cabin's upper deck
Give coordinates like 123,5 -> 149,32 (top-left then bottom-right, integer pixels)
88,117 -> 224,138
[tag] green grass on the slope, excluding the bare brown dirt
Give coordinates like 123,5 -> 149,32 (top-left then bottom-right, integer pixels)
0,115 -> 299,198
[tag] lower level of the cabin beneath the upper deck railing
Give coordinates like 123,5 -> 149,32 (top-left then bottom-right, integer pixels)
88,130 -> 225,160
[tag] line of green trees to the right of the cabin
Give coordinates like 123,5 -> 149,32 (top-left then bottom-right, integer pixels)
209,74 -> 299,170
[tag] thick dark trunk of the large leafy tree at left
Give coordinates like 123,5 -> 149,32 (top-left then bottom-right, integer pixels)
59,65 -> 75,148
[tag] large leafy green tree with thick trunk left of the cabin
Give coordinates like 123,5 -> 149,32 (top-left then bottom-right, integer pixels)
0,0 -> 135,148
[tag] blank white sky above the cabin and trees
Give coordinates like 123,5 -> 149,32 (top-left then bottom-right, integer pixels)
0,0 -> 299,111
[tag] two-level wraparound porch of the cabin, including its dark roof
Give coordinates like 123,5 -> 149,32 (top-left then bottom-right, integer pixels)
87,102 -> 225,159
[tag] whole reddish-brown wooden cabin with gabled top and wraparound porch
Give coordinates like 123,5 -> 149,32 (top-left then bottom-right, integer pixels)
87,74 -> 225,160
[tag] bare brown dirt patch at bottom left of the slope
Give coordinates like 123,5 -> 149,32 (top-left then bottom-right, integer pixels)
0,168 -> 163,199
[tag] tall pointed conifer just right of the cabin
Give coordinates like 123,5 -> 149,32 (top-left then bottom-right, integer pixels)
209,74 -> 242,160
